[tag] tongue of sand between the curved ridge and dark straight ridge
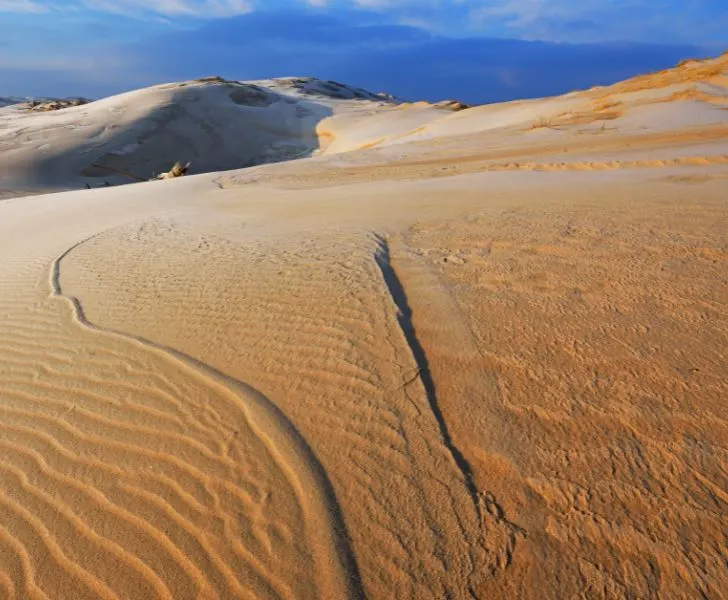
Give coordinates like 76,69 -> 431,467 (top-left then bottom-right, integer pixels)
64,215 -> 517,598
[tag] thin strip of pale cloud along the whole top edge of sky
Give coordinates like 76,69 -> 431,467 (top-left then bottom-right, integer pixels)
0,0 -> 728,44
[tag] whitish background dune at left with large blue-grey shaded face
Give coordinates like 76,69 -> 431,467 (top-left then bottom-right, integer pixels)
0,78 -> 404,191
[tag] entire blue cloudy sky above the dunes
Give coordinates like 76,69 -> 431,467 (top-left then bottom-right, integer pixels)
0,0 -> 728,103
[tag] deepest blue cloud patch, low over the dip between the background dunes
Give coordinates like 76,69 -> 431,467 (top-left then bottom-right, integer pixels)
334,39 -> 697,102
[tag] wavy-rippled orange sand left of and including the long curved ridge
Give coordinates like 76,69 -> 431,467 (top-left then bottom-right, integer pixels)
0,226 -> 359,600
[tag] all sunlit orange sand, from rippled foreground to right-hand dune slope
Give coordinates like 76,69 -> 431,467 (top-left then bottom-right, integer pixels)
0,54 -> 728,600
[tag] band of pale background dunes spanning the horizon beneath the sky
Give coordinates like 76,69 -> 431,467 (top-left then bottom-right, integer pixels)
0,55 -> 728,195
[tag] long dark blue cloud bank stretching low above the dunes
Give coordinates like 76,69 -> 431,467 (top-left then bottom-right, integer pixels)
0,9 -> 706,103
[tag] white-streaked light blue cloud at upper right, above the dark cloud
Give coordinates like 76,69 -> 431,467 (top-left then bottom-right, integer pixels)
304,0 -> 728,44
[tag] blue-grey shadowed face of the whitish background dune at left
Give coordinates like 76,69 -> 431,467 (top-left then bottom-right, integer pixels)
14,80 -> 332,189
